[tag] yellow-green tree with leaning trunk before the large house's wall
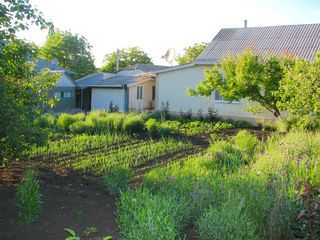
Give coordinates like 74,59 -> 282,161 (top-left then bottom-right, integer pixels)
189,49 -> 292,118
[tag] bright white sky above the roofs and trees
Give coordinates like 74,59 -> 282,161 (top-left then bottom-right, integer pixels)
19,0 -> 320,67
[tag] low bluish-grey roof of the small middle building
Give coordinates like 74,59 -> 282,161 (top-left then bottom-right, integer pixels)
76,64 -> 162,87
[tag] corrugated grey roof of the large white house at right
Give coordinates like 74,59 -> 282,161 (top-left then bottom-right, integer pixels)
194,24 -> 320,64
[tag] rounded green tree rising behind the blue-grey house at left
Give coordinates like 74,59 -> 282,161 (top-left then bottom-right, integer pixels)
40,30 -> 95,78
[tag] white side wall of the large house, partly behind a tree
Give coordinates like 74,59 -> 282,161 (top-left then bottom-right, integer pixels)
156,66 -> 274,120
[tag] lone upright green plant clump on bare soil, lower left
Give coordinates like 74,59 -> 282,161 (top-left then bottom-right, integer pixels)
17,169 -> 41,223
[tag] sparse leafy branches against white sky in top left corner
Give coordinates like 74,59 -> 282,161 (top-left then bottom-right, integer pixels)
0,0 -> 52,41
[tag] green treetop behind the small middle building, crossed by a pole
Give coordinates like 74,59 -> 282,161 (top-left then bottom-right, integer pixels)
101,47 -> 152,72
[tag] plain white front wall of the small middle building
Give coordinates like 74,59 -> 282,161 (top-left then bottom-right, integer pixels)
91,88 -> 125,112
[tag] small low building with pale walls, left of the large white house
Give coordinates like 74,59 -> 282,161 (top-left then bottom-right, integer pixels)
76,64 -> 167,112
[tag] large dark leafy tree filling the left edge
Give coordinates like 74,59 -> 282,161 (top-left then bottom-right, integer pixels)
0,0 -> 59,162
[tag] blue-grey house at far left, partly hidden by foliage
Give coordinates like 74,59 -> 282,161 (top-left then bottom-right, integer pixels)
33,58 -> 76,112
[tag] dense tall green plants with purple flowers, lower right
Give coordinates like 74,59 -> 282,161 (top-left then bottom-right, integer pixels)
118,131 -> 320,240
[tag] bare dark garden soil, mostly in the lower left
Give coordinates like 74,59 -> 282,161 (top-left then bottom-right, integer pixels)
0,130 -> 267,240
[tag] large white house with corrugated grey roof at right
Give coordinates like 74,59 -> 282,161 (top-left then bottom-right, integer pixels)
156,24 -> 320,122
